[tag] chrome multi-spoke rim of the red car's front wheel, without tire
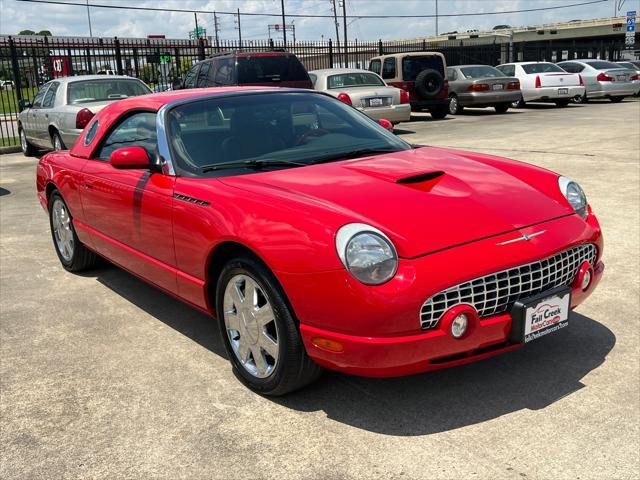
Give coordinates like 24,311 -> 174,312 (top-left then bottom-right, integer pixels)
223,275 -> 279,378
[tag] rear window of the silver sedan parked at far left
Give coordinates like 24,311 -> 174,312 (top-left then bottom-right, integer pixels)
67,78 -> 151,104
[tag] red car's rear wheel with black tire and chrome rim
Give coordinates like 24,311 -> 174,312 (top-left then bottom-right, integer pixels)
49,191 -> 99,272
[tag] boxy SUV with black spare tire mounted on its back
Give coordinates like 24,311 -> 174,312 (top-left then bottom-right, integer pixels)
369,52 -> 449,119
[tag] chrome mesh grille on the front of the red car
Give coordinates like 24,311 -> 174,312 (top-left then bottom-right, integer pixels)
420,243 -> 596,330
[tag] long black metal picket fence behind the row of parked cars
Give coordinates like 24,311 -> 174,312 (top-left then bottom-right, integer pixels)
0,36 -> 624,147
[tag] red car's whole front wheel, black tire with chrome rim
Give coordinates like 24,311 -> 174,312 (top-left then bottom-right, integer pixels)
216,255 -> 322,396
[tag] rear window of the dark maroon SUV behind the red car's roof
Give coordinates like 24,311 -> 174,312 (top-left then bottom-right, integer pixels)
237,55 -> 309,85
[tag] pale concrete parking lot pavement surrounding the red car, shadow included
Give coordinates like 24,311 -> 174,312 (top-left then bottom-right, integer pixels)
0,101 -> 640,480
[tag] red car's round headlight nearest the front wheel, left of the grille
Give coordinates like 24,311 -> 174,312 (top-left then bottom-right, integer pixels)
336,223 -> 398,285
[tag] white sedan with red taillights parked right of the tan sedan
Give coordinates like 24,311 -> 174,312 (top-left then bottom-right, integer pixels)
496,62 -> 584,107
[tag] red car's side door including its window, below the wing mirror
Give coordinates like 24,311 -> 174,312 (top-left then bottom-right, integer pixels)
81,111 -> 176,293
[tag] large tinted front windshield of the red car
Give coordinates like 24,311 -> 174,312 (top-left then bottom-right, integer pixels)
166,91 -> 411,177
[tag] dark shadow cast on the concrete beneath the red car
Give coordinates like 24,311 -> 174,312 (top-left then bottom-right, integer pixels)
84,265 -> 616,436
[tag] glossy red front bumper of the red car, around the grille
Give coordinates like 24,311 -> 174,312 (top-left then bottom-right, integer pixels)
278,215 -> 604,376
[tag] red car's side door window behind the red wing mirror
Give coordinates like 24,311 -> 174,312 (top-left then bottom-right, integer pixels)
97,112 -> 158,161
